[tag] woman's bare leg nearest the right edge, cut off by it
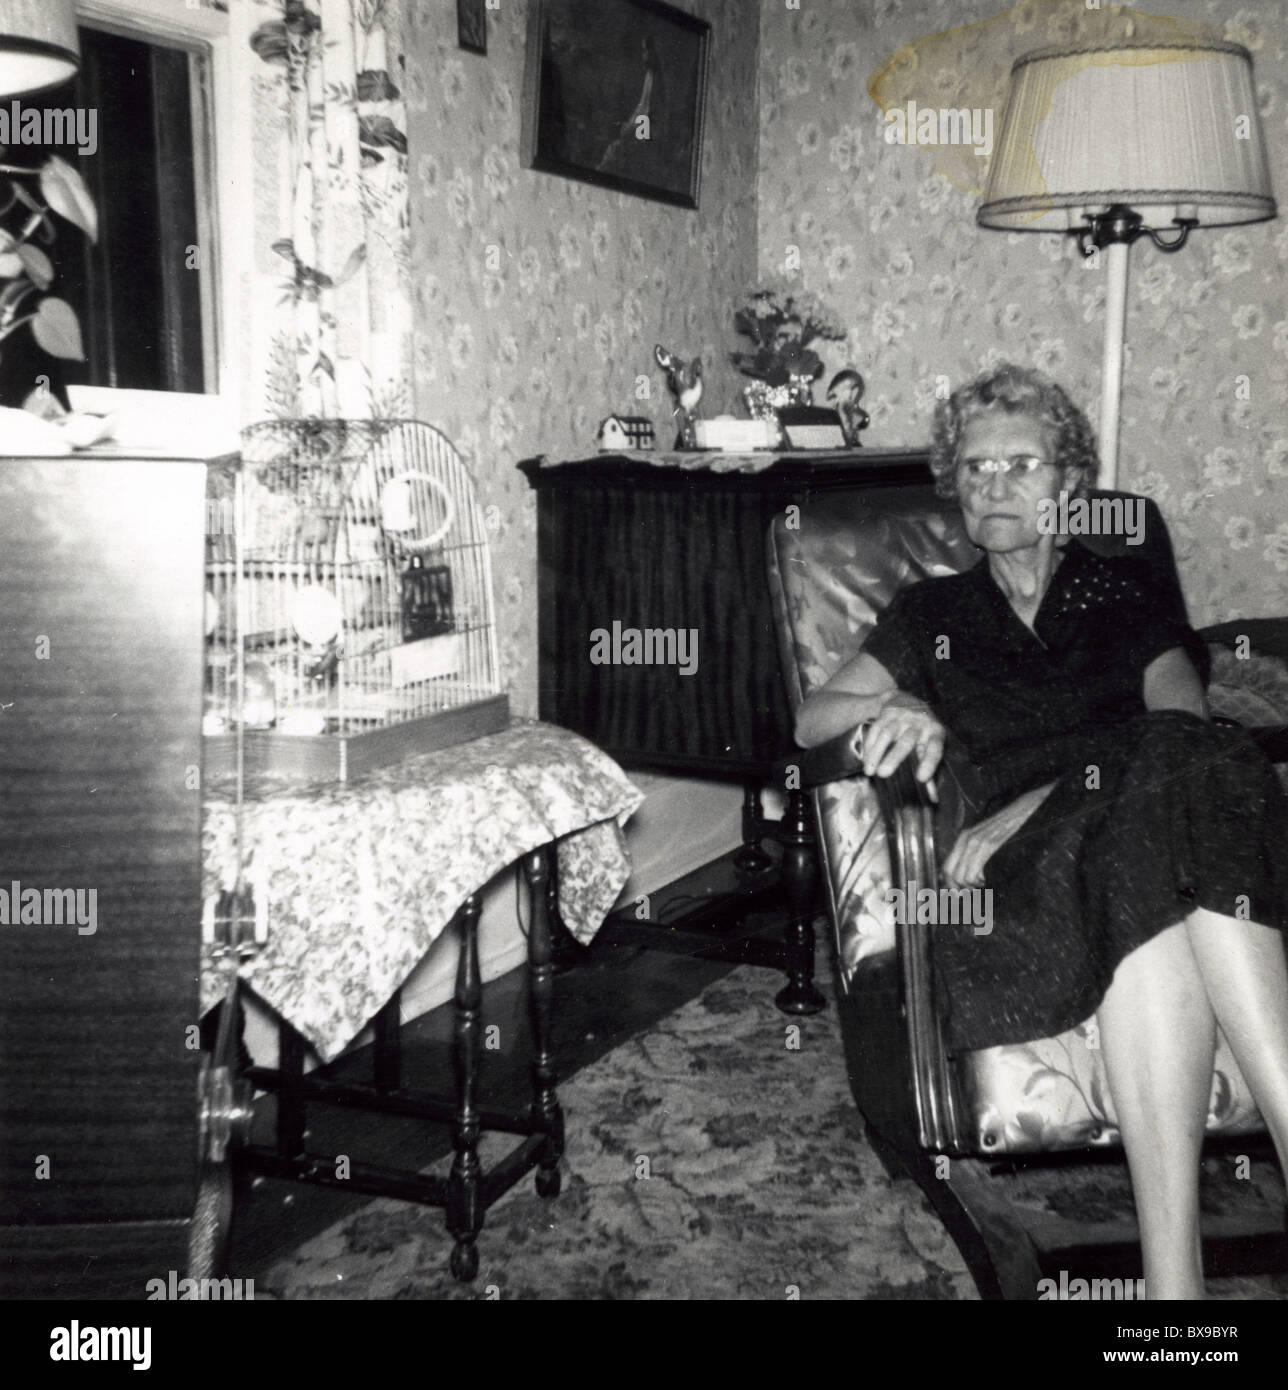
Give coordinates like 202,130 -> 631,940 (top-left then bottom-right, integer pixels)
1185,908 -> 1288,1180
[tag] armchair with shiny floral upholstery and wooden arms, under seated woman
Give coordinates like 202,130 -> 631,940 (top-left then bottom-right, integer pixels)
768,487 -> 1288,1298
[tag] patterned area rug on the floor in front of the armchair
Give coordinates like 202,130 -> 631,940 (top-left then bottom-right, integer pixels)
257,967 -> 1288,1300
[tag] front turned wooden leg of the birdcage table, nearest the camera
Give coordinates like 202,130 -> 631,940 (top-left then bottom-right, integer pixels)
447,895 -> 484,1280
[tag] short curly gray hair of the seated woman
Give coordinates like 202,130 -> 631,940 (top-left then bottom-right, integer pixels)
930,361 -> 1099,502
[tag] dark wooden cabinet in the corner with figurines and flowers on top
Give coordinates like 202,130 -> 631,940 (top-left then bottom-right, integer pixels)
520,449 -> 931,1013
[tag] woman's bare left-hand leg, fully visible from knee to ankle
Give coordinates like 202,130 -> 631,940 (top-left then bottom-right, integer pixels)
1096,923 -> 1216,1298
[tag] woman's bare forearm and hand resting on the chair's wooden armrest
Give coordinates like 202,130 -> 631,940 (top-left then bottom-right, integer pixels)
796,652 -> 943,783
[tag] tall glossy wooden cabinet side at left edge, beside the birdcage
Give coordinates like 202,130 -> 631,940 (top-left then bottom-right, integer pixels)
0,456 -> 206,1298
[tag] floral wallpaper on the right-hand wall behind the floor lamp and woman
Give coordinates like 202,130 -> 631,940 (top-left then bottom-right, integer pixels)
757,0 -> 1288,626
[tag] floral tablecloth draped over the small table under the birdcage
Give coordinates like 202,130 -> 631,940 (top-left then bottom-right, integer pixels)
201,721 -> 643,1062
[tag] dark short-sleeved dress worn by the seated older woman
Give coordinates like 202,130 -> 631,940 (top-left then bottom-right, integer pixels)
864,541 -> 1288,1051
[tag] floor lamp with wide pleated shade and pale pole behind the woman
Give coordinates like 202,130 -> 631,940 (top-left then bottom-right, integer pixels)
975,40 -> 1275,488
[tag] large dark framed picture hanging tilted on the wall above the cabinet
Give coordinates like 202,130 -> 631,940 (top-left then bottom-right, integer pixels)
522,0 -> 711,207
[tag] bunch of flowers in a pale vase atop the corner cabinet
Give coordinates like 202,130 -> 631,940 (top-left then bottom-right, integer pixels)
729,278 -> 845,420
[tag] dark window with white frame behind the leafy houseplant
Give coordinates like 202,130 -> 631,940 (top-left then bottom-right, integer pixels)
0,0 -> 228,407
